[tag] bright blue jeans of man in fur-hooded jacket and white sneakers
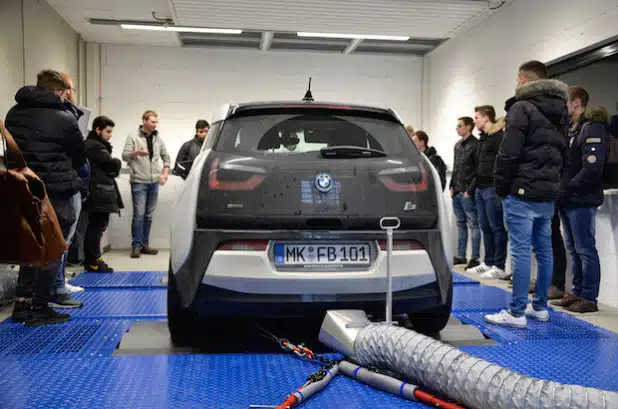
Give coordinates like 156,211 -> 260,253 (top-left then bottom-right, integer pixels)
504,196 -> 554,317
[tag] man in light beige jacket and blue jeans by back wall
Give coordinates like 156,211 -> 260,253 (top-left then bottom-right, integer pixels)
122,111 -> 171,258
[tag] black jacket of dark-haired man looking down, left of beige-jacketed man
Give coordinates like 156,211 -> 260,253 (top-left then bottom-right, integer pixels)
85,131 -> 124,213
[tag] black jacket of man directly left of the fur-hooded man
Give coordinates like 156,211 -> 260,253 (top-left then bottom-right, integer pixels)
472,118 -> 505,190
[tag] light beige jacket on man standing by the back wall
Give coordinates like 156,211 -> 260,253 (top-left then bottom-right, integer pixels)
122,126 -> 172,183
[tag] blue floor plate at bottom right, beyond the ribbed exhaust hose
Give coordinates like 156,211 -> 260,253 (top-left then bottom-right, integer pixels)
461,338 -> 618,391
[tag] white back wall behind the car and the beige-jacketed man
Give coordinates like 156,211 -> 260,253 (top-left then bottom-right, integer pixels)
101,45 -> 422,248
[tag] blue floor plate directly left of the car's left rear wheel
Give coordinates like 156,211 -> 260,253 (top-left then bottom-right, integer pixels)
58,288 -> 167,319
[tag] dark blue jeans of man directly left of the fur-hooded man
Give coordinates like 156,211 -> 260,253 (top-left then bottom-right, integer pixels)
474,187 -> 506,270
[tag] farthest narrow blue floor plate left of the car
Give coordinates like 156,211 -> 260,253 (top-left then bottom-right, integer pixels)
70,271 -> 166,288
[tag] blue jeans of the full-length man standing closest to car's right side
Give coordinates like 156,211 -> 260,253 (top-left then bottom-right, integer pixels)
453,193 -> 481,259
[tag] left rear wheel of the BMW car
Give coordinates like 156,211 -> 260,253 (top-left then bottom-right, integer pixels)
167,266 -> 199,347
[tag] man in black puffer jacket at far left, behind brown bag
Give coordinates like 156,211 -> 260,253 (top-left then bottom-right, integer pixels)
5,70 -> 86,325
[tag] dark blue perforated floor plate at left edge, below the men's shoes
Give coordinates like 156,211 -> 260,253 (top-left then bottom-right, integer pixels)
0,320 -> 132,357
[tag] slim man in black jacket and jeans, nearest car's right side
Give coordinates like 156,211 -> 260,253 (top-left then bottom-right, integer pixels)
449,116 -> 481,269
